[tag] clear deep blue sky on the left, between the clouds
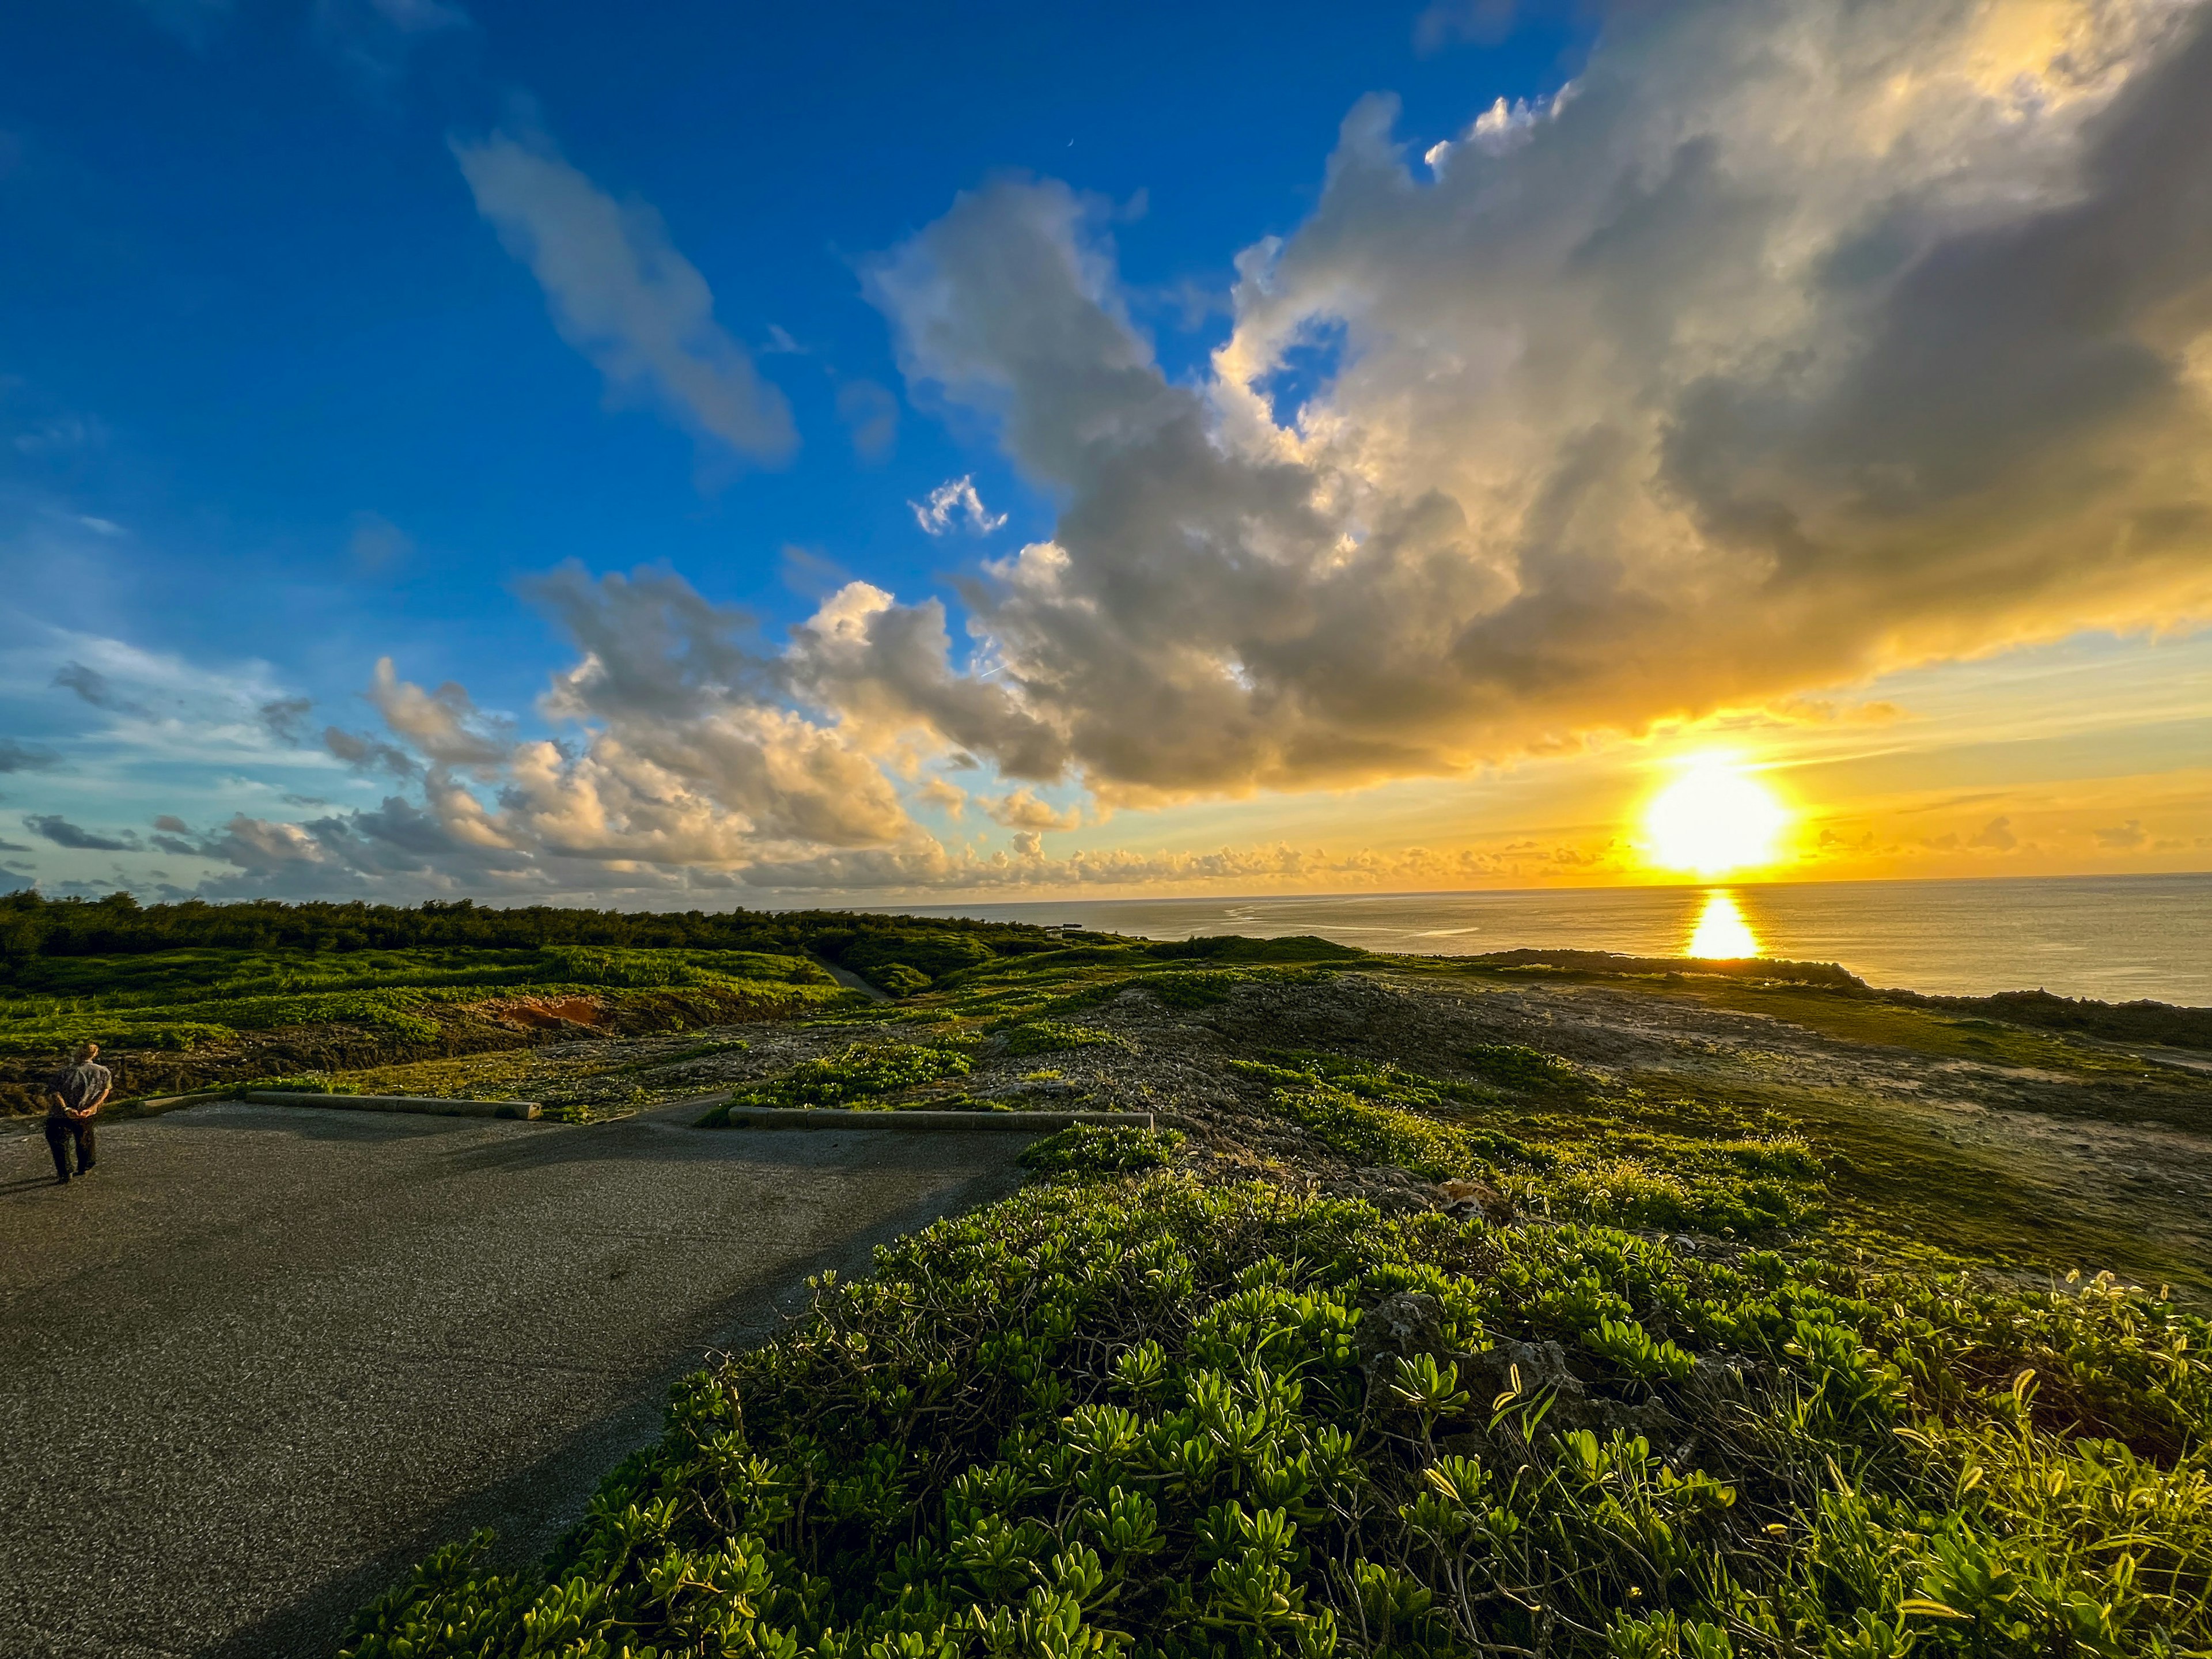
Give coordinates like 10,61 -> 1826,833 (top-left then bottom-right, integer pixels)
0,0 -> 1570,712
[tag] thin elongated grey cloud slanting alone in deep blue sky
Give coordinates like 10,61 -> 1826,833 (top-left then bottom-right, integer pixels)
451,131 -> 798,463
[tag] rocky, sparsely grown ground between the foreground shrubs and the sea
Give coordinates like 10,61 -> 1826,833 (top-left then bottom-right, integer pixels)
251,964 -> 2212,1294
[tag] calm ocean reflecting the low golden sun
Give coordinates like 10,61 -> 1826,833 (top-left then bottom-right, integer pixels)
900,874 -> 2212,1006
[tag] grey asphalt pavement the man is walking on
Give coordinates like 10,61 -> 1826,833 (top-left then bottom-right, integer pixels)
0,1104 -> 1024,1659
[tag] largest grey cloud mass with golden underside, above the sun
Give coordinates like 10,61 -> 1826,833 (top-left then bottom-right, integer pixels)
796,0 -> 2212,803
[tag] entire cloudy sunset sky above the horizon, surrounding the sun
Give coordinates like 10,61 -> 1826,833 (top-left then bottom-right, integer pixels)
0,0 -> 2212,909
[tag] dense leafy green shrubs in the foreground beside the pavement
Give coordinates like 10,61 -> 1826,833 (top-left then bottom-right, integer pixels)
345,1177 -> 2212,1659
